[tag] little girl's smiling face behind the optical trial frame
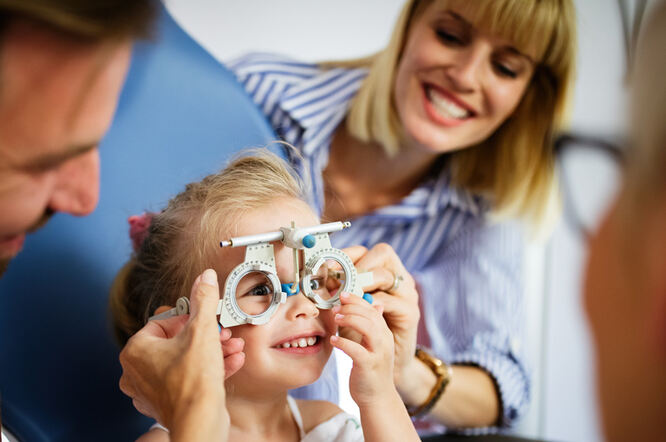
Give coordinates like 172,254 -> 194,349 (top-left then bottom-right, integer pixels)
216,198 -> 337,396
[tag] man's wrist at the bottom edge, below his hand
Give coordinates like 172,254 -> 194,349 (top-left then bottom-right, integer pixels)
169,396 -> 229,442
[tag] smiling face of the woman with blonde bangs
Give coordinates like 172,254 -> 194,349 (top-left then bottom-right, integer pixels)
395,2 -> 534,153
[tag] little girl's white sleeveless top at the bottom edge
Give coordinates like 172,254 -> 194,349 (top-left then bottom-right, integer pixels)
150,396 -> 363,442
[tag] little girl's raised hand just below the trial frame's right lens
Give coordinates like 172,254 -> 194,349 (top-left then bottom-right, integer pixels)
331,292 -> 395,408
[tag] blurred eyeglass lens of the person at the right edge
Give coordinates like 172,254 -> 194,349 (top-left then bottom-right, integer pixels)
555,134 -> 624,238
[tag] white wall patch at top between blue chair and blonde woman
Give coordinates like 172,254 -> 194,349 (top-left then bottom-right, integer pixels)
165,0 -> 403,61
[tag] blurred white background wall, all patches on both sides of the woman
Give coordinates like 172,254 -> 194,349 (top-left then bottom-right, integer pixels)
166,0 -> 636,442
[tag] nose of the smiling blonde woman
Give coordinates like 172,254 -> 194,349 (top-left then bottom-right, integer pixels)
446,41 -> 490,92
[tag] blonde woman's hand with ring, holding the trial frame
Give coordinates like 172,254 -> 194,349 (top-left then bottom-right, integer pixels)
344,243 -> 421,385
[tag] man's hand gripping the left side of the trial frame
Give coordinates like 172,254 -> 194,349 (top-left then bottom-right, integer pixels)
120,270 -> 244,440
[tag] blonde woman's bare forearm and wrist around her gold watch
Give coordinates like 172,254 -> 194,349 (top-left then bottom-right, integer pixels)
396,358 -> 500,428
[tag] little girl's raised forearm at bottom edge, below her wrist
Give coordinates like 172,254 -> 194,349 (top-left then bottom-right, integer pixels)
359,388 -> 420,442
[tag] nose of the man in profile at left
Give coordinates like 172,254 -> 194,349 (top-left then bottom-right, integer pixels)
49,149 -> 99,216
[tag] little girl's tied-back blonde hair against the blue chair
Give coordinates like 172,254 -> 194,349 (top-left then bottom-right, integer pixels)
109,149 -> 305,344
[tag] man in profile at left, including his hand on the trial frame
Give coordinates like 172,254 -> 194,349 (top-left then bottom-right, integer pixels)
0,0 -> 243,441
